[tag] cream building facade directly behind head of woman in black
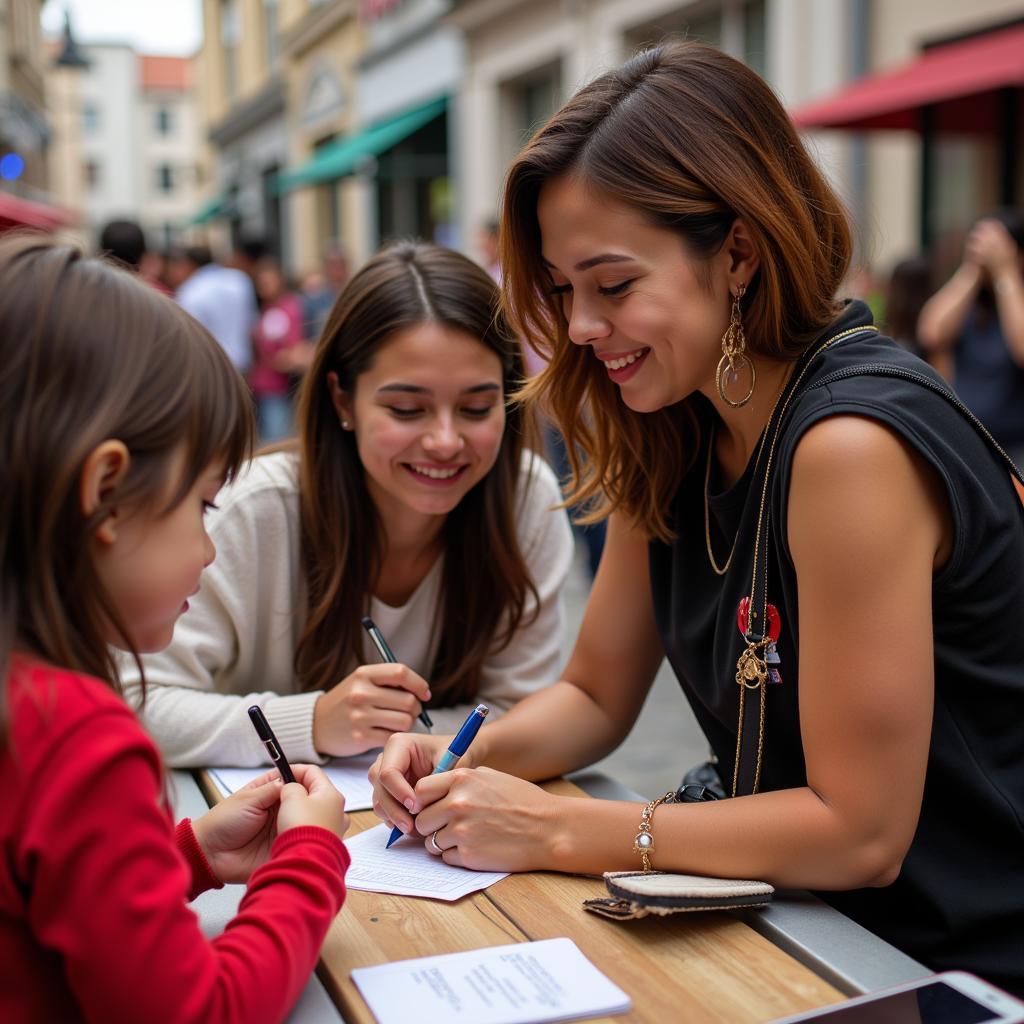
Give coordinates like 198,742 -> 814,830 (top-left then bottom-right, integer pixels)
452,0 -> 858,268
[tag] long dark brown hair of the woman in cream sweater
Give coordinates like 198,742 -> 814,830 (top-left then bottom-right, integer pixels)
295,242 -> 538,703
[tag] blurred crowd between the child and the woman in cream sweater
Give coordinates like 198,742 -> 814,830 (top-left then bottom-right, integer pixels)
99,220 -> 348,444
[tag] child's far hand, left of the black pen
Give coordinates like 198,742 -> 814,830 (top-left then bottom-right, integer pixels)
193,768 -> 284,882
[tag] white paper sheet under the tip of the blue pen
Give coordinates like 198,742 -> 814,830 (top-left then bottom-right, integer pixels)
345,824 -> 508,900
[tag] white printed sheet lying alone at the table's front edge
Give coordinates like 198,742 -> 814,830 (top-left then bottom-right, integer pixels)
352,939 -> 633,1024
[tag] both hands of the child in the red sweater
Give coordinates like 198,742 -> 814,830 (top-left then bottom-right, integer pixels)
193,765 -> 348,883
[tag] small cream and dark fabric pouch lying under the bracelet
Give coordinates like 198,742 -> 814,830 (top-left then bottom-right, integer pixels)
583,871 -> 775,921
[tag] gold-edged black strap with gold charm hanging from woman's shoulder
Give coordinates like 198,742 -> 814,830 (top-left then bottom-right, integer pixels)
729,326 -> 878,797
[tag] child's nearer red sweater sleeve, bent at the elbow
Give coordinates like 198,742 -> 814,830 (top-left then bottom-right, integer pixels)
18,692 -> 348,1024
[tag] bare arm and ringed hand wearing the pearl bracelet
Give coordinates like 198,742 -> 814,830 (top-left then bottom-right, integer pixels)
414,417 -> 950,889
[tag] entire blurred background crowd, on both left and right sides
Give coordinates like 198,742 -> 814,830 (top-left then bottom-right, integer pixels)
100,210 -> 1024,473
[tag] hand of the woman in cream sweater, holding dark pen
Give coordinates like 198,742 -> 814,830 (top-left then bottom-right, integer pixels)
313,664 -> 430,758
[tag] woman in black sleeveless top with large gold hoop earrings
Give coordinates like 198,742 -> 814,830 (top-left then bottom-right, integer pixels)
371,43 -> 1024,991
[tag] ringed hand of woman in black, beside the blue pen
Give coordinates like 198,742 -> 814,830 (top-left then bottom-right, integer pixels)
414,767 -> 567,871
